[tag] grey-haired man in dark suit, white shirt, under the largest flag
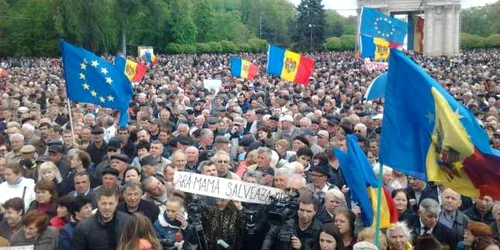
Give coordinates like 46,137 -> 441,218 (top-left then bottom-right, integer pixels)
412,198 -> 458,250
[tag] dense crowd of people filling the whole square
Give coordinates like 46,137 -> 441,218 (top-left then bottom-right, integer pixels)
0,50 -> 500,250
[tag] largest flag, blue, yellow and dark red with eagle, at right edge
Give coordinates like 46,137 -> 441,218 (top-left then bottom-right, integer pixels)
379,49 -> 500,200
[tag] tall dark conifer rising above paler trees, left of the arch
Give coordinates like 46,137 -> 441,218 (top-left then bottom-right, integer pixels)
292,0 -> 325,51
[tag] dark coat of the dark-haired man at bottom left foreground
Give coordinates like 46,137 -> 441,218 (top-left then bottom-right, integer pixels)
71,211 -> 130,250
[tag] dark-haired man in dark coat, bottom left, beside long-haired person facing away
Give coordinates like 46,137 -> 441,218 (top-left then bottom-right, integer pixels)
71,188 -> 130,250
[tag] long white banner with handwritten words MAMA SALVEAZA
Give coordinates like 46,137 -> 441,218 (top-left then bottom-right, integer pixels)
174,172 -> 285,204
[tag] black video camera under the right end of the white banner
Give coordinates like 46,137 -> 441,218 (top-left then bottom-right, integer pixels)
267,191 -> 300,226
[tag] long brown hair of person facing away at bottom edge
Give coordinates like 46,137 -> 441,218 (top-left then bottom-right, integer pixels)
117,213 -> 163,250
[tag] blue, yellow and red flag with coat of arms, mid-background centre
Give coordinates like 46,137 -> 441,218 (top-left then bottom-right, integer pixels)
267,44 -> 314,85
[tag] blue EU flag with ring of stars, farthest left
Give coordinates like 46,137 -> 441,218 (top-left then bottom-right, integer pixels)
60,40 -> 133,127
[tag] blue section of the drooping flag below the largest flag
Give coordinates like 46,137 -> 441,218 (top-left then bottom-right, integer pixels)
334,135 -> 378,226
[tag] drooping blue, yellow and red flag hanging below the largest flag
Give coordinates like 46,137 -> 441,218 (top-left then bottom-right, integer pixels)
334,135 -> 398,228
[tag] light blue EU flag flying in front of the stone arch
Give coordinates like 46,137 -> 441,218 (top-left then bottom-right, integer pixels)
360,7 -> 408,44
